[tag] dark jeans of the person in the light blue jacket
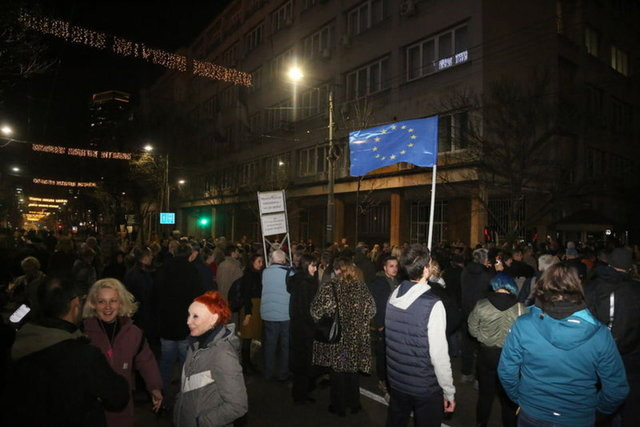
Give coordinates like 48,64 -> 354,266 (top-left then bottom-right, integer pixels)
263,320 -> 290,380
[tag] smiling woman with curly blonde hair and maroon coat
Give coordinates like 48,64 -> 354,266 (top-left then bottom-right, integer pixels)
82,278 -> 162,427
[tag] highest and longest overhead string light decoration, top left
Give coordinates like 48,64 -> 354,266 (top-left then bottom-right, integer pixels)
18,10 -> 252,87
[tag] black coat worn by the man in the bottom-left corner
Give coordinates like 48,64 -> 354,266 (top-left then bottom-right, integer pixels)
0,320 -> 129,427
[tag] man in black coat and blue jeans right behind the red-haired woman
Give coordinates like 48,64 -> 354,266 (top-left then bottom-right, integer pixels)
153,242 -> 205,399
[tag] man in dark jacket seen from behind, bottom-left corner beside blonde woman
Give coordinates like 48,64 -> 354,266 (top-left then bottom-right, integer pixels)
0,281 -> 129,426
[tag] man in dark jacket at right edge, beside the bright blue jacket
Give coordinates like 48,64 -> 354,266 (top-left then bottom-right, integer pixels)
584,248 -> 640,426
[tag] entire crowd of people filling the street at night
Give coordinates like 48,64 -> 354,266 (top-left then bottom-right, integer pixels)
0,231 -> 640,426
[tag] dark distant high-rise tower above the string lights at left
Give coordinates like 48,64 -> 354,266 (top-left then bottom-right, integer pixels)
89,90 -> 132,150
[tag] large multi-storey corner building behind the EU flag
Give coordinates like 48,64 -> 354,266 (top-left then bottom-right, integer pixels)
143,0 -> 640,245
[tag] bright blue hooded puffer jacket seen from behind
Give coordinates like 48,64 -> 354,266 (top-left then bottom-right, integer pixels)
498,306 -> 629,426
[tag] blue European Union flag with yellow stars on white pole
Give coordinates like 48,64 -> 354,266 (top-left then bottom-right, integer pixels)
349,116 -> 438,176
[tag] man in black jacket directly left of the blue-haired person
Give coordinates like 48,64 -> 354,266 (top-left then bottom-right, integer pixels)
461,248 -> 493,383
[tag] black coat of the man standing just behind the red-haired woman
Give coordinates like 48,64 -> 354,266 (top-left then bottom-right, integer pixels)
153,257 -> 205,341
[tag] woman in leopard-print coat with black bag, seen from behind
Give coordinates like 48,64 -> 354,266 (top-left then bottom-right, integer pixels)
311,262 -> 376,417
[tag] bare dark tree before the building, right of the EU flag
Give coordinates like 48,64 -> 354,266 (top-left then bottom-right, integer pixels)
439,75 -> 575,242
